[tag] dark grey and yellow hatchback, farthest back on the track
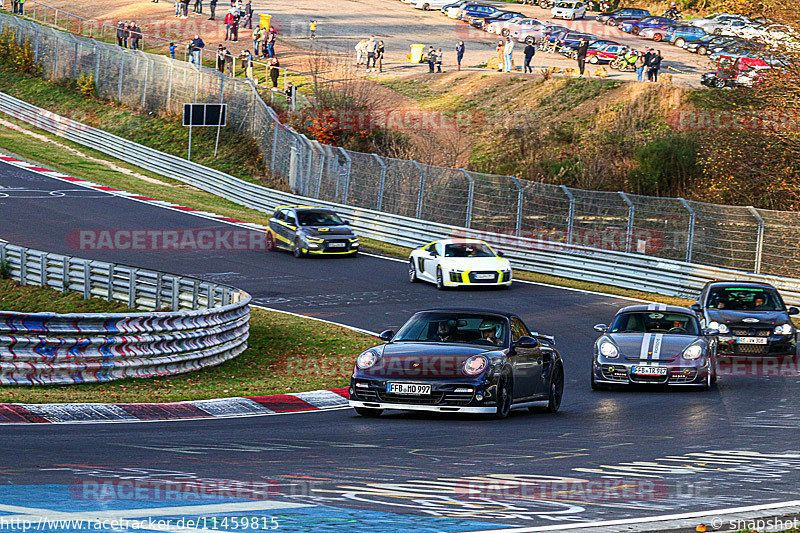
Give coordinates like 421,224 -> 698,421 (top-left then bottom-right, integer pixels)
266,205 -> 359,257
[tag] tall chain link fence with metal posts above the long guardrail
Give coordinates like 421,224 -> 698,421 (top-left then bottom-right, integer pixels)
0,14 -> 800,276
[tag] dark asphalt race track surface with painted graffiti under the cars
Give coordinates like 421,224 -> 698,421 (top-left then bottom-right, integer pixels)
0,159 -> 800,532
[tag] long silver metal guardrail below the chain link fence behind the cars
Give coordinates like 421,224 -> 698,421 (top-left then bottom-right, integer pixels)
0,93 -> 800,305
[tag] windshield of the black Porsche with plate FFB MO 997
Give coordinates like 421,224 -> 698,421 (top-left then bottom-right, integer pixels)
393,313 -> 508,346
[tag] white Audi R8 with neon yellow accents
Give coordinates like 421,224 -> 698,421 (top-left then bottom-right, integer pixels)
408,239 -> 512,289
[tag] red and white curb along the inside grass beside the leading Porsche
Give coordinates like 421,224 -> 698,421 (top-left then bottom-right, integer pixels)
0,387 -> 349,425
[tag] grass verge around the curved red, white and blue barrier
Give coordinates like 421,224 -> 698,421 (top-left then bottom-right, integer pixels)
0,280 -> 374,403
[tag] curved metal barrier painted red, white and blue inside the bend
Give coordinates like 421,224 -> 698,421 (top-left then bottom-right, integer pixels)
0,242 -> 250,385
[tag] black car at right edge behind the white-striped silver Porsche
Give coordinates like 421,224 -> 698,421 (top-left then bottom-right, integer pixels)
692,281 -> 800,356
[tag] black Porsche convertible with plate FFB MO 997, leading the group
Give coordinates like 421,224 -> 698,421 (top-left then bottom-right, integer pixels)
350,309 -> 564,418
